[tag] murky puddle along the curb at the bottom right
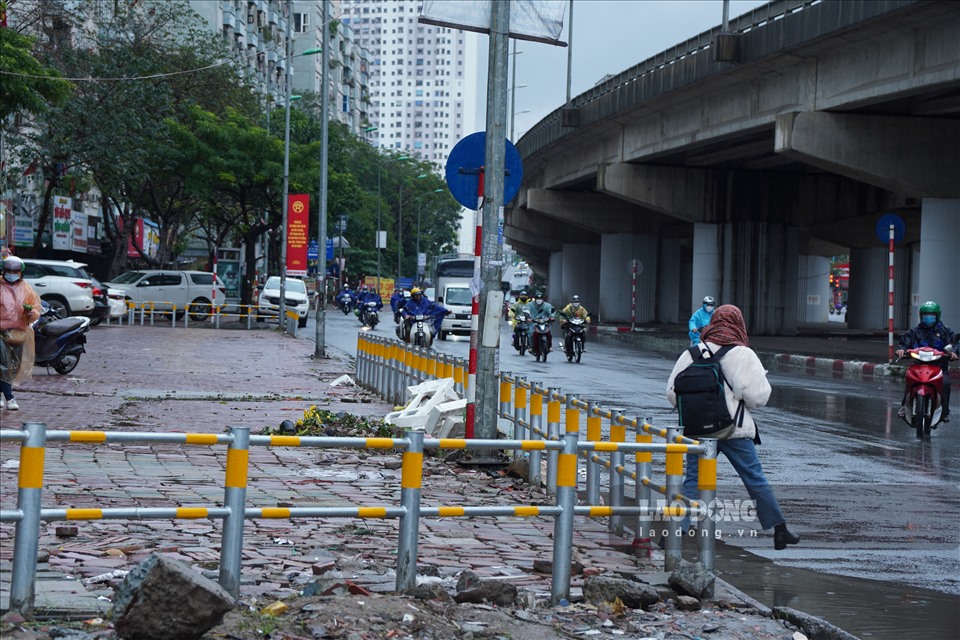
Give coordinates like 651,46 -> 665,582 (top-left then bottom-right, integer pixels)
716,542 -> 960,640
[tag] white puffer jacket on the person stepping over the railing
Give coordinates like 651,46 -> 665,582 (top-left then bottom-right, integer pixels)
667,342 -> 771,440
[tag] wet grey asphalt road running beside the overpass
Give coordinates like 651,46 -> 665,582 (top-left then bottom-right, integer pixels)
306,313 -> 960,638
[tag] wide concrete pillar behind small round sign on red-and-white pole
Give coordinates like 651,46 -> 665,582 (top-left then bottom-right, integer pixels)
596,233 -> 658,324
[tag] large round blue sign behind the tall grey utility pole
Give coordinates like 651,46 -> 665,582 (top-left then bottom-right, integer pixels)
445,131 -> 523,211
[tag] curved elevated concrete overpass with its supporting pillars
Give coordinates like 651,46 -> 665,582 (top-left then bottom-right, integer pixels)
504,0 -> 960,335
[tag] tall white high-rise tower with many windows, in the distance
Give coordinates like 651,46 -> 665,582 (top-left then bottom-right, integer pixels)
341,0 -> 476,165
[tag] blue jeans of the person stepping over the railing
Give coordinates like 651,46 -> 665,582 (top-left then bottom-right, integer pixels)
683,438 -> 787,530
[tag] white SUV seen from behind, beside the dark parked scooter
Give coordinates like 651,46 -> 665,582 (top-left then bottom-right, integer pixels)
23,258 -> 96,318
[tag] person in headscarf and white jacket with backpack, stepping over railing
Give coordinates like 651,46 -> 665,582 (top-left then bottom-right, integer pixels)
667,304 -> 800,550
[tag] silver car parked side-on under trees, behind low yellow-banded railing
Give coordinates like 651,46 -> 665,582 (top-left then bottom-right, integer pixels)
105,269 -> 227,322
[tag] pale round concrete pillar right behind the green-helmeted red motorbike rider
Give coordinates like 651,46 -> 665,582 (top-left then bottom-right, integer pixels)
910,198 -> 960,331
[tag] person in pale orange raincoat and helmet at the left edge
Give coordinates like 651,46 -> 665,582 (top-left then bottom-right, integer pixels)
0,255 -> 41,411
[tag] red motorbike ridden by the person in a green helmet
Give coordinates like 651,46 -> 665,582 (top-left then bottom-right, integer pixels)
903,345 -> 953,439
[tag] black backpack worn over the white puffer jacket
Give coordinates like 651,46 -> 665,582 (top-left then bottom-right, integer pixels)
673,345 -> 743,438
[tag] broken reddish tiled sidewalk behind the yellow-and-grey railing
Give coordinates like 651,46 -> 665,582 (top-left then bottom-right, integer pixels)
0,326 -> 680,615
